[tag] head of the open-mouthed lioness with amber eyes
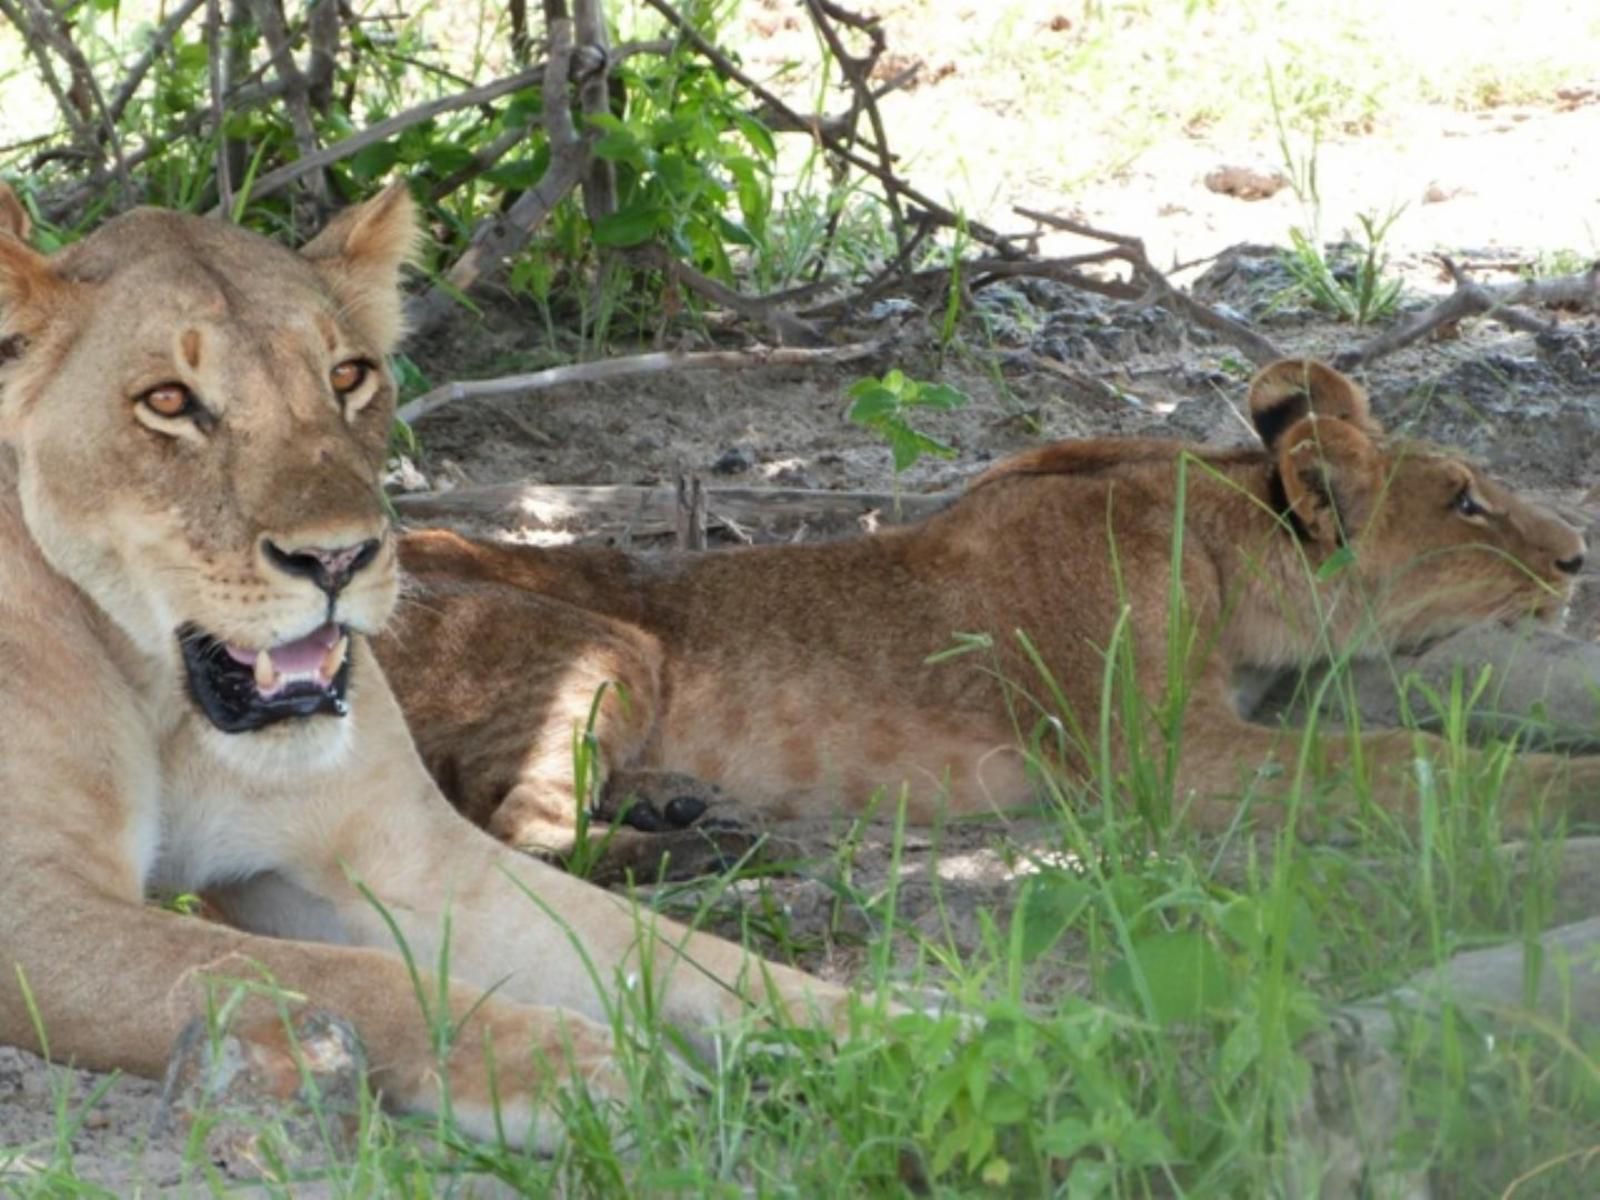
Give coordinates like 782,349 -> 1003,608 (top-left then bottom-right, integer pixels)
0,189 -> 414,733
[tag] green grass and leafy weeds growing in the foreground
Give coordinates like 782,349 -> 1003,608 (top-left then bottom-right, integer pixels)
0,643 -> 1600,1198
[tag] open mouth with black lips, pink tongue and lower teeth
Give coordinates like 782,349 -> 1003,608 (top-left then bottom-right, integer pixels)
178,622 -> 350,733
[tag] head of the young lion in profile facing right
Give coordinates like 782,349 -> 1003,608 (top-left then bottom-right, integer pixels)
1250,358 -> 1584,645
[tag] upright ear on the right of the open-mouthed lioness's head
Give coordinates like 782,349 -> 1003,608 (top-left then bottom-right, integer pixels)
301,182 -> 421,352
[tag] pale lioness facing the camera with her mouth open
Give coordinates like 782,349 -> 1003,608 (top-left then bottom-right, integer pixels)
0,187 -> 845,1146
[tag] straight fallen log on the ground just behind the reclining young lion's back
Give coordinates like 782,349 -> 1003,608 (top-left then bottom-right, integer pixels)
392,483 -> 955,538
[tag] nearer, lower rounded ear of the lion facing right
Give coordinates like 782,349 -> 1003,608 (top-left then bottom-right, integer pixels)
1278,414 -> 1384,546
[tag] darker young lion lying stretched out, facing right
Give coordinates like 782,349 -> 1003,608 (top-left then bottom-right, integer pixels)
378,360 -> 1600,851
